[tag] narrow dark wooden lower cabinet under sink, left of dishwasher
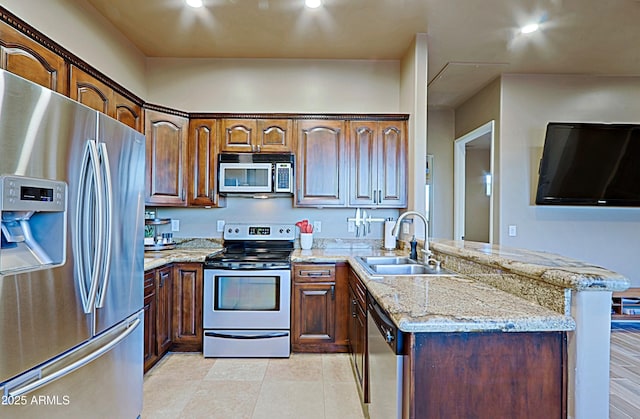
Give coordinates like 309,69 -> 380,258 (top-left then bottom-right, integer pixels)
348,269 -> 369,403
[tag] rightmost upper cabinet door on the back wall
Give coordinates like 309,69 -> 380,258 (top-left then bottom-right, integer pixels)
377,121 -> 407,208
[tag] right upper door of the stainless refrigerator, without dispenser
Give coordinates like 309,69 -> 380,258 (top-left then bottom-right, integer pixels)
96,114 -> 145,333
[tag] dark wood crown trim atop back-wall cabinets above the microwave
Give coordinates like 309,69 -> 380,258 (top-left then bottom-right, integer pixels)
190,112 -> 409,121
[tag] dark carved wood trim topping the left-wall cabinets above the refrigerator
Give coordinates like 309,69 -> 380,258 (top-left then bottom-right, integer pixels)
0,6 -> 144,106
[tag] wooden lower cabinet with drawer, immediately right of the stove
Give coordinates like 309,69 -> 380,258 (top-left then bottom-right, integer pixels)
291,263 -> 349,353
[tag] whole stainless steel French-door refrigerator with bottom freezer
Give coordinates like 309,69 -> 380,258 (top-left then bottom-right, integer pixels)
0,70 -> 145,418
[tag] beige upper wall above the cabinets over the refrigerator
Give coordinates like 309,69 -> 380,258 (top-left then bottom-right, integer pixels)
2,0 -> 147,99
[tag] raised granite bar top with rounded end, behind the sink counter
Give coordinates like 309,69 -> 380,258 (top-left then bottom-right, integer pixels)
430,239 -> 630,291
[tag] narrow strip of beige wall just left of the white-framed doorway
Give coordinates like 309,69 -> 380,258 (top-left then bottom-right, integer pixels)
427,109 -> 455,239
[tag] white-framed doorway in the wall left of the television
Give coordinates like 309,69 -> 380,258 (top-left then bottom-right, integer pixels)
453,121 -> 494,243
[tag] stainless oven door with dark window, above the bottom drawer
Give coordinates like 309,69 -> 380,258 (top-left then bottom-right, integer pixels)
202,269 -> 291,330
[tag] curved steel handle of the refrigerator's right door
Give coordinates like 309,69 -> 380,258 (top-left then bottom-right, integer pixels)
96,143 -> 113,308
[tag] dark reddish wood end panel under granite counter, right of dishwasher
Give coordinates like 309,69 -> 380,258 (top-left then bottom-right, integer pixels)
403,332 -> 567,418
